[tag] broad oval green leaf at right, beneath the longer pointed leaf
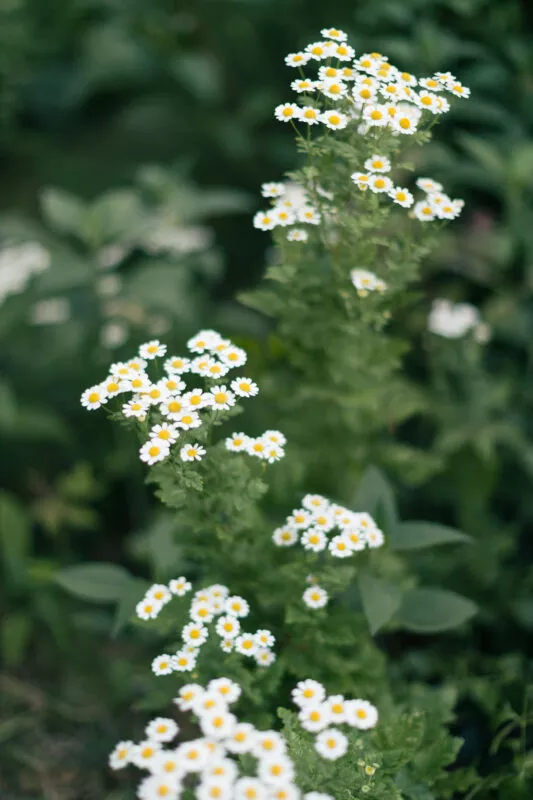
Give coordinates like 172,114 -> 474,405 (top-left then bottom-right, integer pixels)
396,588 -> 478,633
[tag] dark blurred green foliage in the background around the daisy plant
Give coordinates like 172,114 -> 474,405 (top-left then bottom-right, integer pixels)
0,0 -> 533,800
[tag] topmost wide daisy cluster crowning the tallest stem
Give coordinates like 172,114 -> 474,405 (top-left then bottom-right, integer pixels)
274,28 -> 470,135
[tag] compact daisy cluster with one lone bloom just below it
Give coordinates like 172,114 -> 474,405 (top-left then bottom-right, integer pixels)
272,494 -> 385,609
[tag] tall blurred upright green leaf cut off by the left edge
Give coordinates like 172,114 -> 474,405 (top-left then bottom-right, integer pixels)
0,492 -> 31,582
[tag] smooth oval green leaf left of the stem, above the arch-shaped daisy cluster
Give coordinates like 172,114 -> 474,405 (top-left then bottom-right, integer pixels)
55,563 -> 133,603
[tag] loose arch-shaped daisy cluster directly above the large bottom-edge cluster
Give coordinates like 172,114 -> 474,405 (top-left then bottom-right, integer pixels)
136,577 -> 276,675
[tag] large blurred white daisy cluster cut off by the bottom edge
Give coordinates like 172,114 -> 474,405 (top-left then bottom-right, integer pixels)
109,678 -> 333,800
